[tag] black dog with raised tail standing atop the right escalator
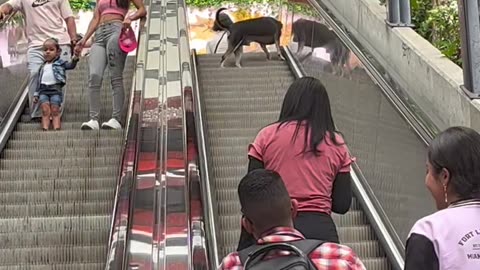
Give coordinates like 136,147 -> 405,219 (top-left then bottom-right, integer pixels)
215,8 -> 285,68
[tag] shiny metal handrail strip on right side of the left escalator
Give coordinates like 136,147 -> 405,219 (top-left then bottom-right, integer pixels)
104,17 -> 148,270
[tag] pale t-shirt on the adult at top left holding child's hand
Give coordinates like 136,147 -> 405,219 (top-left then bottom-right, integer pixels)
8,0 -> 73,47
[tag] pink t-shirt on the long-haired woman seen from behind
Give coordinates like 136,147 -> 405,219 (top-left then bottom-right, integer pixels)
248,122 -> 354,214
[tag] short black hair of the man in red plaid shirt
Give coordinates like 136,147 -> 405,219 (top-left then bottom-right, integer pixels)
238,169 -> 291,229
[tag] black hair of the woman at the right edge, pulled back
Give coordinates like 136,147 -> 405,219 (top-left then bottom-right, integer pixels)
428,127 -> 480,200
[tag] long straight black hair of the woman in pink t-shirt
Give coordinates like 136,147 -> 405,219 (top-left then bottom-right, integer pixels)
277,77 -> 340,156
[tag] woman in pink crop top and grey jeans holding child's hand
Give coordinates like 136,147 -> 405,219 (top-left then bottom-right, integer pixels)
75,0 -> 146,130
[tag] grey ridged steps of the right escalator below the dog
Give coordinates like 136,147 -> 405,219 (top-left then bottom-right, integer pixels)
197,53 -> 391,270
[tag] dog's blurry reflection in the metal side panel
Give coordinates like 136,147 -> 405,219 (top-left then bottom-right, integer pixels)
292,19 -> 351,77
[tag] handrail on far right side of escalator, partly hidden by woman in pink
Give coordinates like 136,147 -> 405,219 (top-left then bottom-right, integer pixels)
283,47 -> 405,270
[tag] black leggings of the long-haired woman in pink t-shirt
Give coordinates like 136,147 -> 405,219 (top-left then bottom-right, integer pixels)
237,212 -> 339,251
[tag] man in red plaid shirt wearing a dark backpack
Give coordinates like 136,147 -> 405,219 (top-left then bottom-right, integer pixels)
219,169 -> 365,270
